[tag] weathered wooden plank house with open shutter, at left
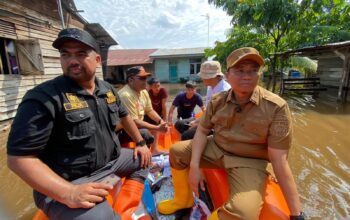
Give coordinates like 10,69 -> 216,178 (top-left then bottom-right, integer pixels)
0,0 -> 117,144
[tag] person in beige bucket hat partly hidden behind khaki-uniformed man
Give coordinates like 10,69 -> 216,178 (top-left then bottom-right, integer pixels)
176,61 -> 231,141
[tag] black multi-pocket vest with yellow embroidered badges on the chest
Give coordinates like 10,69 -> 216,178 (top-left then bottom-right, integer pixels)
23,76 -> 120,181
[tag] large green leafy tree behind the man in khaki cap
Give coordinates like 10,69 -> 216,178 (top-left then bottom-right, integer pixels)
207,0 -> 350,91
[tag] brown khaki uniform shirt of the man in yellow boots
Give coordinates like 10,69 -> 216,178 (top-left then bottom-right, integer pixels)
200,86 -> 292,160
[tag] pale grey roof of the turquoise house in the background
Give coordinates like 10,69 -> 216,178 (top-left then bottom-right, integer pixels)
150,47 -> 205,58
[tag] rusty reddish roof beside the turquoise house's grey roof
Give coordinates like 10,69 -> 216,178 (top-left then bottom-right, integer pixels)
107,49 -> 157,66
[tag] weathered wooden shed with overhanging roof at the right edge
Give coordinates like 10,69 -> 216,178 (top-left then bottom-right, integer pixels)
276,41 -> 350,102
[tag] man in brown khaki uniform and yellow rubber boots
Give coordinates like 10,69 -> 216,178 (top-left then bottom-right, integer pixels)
158,47 -> 304,220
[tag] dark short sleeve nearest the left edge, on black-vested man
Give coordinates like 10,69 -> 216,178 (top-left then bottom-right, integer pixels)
7,99 -> 53,156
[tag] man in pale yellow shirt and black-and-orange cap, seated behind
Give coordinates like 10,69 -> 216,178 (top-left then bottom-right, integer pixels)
118,66 -> 168,154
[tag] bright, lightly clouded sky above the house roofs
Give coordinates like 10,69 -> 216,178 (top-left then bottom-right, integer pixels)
74,0 -> 231,49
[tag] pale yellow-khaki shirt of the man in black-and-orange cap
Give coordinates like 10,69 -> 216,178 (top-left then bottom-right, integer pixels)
118,84 -> 153,120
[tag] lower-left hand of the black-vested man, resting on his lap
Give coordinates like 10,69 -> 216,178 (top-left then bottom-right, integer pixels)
61,183 -> 113,208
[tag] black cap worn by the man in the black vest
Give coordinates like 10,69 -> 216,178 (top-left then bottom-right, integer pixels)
52,28 -> 98,52
